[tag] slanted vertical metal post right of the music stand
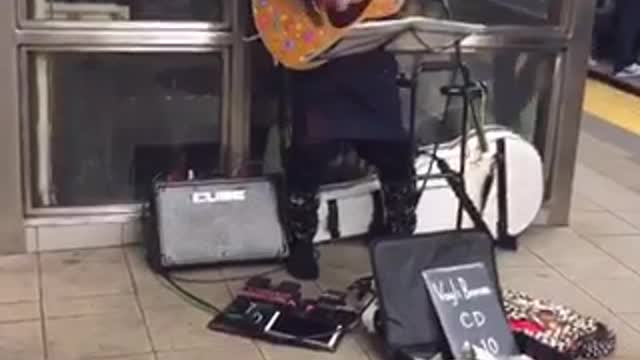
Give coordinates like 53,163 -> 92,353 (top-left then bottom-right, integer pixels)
545,0 -> 595,226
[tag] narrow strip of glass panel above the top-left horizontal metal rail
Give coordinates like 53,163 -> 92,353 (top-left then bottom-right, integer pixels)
28,0 -> 226,22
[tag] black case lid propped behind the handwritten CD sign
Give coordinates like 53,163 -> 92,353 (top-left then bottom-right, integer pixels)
369,230 -> 500,360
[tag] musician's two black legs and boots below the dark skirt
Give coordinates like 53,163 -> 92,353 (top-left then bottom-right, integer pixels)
287,140 -> 418,279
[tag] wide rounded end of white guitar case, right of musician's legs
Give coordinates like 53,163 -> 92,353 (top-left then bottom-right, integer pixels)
416,125 -> 544,239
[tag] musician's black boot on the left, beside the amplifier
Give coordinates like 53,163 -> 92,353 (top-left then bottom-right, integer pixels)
287,192 -> 320,280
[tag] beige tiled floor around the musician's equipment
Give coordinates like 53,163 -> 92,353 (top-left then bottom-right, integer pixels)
0,130 -> 640,360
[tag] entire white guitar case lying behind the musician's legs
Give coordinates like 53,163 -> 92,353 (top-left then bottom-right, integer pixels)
314,126 -> 543,243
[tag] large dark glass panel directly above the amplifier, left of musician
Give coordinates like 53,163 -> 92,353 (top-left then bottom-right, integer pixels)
28,52 -> 225,207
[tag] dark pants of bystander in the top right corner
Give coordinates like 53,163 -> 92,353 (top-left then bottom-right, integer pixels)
614,0 -> 640,73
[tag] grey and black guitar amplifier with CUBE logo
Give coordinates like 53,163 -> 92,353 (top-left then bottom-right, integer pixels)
145,178 -> 288,272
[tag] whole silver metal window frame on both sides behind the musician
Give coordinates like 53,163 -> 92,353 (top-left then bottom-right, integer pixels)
0,0 -> 595,253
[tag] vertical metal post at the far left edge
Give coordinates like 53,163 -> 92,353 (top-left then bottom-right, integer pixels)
0,0 -> 26,254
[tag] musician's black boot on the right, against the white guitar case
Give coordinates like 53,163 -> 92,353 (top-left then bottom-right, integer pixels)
382,181 -> 420,236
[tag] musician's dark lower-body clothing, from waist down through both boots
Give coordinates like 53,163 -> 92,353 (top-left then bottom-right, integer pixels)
287,50 -> 417,279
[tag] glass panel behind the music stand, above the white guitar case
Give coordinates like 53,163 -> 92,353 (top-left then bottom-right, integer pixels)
399,51 -> 554,148
